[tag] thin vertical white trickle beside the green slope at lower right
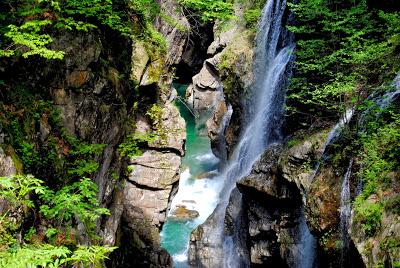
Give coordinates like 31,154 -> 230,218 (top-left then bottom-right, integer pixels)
340,159 -> 353,267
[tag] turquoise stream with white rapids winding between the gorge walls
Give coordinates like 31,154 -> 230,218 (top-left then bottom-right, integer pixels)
161,84 -> 222,268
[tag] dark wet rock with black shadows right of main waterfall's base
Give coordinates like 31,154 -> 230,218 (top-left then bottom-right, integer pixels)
237,146 -> 302,267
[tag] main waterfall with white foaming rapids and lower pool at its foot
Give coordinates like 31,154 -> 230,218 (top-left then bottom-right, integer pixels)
162,0 -> 294,267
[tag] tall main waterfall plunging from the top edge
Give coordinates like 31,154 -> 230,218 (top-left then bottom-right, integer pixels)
217,0 -> 294,267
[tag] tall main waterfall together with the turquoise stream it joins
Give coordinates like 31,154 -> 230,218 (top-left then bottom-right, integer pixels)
161,0 -> 302,267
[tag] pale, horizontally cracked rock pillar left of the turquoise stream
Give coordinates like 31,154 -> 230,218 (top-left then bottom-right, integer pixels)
113,100 -> 185,267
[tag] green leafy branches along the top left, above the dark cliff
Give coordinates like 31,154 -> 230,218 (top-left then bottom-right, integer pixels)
0,0 -> 166,59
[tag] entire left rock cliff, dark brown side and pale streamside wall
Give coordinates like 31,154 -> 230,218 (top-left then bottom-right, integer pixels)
0,1 -> 187,267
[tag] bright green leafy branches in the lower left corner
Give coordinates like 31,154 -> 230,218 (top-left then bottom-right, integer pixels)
0,175 -> 115,268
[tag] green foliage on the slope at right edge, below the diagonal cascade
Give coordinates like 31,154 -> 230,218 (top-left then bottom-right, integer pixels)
354,110 -> 400,236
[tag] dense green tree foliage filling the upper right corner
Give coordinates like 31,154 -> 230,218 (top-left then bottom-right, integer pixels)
287,0 -> 400,123
